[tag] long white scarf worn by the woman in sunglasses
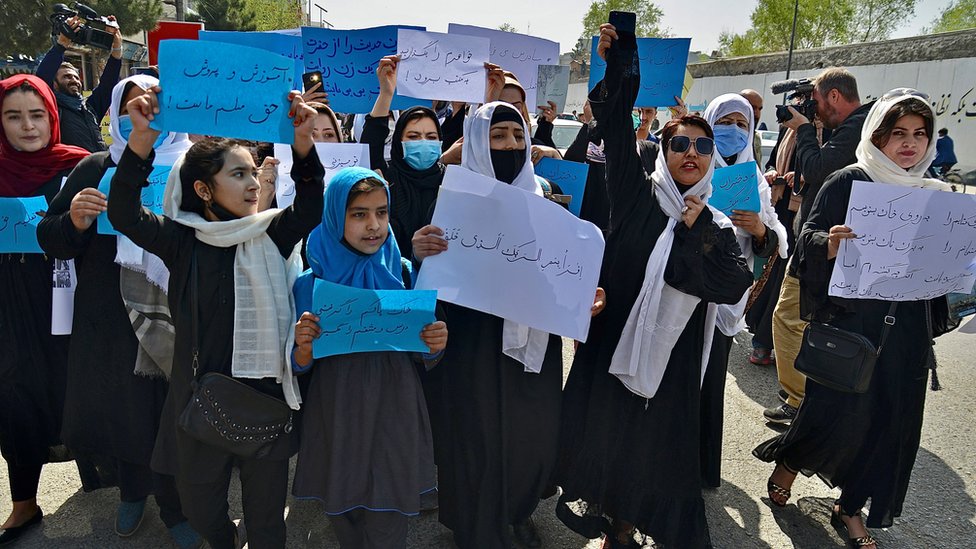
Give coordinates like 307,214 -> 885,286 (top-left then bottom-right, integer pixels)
610,141 -> 732,398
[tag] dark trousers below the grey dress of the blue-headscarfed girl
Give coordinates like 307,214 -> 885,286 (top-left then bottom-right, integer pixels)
329,509 -> 407,549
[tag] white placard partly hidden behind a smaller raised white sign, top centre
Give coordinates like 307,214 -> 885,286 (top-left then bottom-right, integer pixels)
447,23 -> 559,108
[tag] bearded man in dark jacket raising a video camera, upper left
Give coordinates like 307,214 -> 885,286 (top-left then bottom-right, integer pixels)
37,16 -> 122,152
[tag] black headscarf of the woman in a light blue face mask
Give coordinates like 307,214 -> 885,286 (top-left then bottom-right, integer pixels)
384,107 -> 444,257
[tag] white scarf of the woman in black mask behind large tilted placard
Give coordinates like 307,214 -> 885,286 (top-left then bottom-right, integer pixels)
461,101 -> 549,374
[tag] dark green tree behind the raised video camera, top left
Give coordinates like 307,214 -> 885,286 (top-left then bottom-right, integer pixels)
0,0 -> 163,55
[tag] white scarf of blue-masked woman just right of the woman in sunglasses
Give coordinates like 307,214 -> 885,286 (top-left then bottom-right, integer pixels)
703,93 -> 789,337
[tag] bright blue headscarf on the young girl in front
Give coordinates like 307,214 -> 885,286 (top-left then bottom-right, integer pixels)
295,167 -> 404,316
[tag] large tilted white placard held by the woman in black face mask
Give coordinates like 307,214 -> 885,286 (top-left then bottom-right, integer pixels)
417,166 -> 604,341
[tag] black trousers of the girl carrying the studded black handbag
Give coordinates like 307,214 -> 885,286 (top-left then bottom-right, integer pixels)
176,457 -> 288,549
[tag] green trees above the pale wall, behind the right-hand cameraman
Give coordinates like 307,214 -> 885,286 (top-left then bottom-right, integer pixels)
719,0 -> 916,56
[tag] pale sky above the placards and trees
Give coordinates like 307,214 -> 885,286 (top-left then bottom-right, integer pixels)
311,0 -> 951,53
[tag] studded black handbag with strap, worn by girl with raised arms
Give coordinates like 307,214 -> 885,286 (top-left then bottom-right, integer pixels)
178,249 -> 292,458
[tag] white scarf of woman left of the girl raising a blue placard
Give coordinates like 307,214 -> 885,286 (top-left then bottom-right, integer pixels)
108,74 -> 193,292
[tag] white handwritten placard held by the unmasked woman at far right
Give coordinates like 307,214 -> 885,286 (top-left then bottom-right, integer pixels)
828,181 -> 976,301
